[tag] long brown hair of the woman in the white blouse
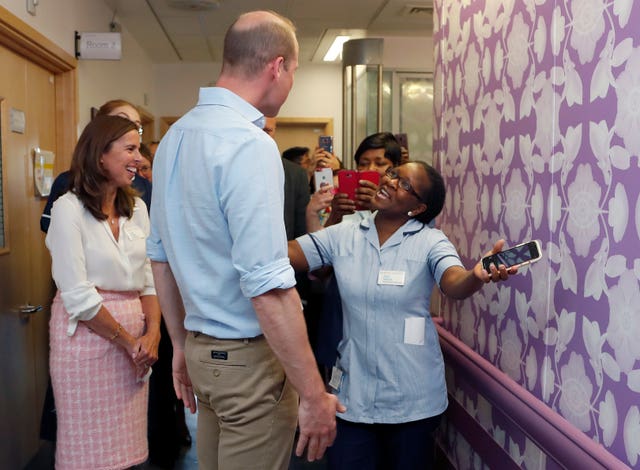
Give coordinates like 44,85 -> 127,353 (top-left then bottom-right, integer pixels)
70,115 -> 138,220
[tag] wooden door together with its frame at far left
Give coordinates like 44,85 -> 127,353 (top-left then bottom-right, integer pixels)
0,7 -> 77,468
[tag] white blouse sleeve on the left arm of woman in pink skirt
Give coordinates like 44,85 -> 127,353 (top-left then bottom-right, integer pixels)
46,198 -> 102,336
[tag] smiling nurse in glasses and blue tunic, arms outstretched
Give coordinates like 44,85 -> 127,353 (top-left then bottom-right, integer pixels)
289,162 -> 516,470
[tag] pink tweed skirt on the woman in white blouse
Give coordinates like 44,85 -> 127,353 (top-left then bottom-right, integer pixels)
49,291 -> 149,470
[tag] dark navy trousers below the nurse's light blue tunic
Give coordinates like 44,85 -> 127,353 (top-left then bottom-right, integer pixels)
328,415 -> 440,470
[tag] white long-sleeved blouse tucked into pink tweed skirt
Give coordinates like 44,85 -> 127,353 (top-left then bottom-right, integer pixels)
45,191 -> 156,336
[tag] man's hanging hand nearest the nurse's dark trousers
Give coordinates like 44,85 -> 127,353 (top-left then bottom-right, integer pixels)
296,392 -> 347,462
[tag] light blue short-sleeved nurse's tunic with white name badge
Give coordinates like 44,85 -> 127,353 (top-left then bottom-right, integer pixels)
297,214 -> 462,423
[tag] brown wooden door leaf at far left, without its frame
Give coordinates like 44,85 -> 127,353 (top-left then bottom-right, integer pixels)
0,45 -> 56,468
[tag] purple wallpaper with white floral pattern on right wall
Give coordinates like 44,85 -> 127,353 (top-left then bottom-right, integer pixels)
434,0 -> 640,468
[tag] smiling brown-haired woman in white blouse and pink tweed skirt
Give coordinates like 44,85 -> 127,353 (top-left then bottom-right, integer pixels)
46,116 -> 160,469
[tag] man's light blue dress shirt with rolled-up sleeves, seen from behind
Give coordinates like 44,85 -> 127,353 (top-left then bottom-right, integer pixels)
147,87 -> 295,338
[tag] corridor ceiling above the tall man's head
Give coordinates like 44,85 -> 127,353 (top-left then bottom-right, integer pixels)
104,0 -> 433,63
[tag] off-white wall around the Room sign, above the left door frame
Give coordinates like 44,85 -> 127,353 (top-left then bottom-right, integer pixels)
2,0 -> 155,134
